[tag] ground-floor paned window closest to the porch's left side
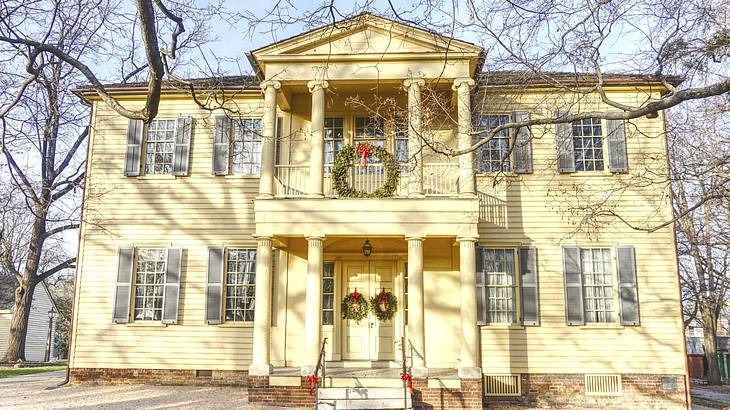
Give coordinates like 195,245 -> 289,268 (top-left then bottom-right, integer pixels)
225,249 -> 256,322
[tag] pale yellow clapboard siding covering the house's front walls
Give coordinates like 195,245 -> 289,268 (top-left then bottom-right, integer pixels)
71,88 -> 684,374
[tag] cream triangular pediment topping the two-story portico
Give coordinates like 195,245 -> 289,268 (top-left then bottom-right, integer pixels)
252,14 -> 482,59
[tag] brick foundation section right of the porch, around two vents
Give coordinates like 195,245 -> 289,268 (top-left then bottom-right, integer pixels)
485,374 -> 687,409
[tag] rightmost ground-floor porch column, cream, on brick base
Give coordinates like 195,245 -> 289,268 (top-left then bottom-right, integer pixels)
457,237 -> 482,379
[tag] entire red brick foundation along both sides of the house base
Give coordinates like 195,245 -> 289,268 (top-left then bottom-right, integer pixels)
71,368 -> 687,410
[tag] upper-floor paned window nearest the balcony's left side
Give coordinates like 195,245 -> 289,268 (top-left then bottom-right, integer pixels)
231,118 -> 261,175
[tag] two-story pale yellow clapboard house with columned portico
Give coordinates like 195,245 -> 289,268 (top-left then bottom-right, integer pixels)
70,14 -> 688,408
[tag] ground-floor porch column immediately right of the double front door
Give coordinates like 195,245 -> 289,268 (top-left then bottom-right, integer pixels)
406,236 -> 428,378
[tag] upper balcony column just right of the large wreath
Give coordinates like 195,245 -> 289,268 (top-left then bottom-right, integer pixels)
403,78 -> 426,197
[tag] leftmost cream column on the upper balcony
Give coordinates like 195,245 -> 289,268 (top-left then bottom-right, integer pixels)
258,80 -> 281,198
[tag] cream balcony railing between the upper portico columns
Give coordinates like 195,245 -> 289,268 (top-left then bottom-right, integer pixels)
275,163 -> 459,198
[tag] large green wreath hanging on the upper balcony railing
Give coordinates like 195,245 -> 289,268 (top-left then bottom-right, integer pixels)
332,143 -> 400,198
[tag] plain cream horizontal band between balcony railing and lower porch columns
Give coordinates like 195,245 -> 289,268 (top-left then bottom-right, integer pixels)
254,198 -> 479,237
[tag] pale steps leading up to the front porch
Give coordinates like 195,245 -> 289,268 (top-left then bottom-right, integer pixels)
317,387 -> 413,409
